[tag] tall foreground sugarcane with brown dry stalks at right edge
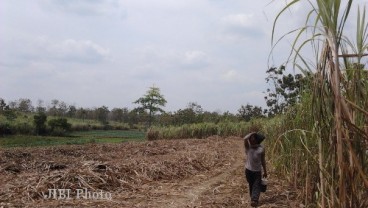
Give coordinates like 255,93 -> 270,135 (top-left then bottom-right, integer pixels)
272,0 -> 368,207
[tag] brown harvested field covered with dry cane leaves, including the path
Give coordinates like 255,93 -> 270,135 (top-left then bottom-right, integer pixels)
0,137 -> 299,208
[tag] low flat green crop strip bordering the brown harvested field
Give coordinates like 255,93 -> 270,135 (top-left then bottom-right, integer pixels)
0,130 -> 145,147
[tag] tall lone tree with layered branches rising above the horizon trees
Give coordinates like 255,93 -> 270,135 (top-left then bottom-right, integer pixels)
134,86 -> 167,126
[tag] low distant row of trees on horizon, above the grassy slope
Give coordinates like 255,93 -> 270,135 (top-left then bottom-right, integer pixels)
0,98 -> 263,125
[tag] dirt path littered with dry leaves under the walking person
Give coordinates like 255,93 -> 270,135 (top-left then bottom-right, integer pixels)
141,138 -> 299,208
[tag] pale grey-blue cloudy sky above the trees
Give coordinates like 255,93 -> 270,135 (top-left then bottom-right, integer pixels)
0,0 -> 365,113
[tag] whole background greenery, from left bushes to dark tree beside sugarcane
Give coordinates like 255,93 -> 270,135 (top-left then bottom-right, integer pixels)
0,66 -> 304,134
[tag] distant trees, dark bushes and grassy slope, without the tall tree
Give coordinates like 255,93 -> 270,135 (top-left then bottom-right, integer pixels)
0,91 -> 265,136
